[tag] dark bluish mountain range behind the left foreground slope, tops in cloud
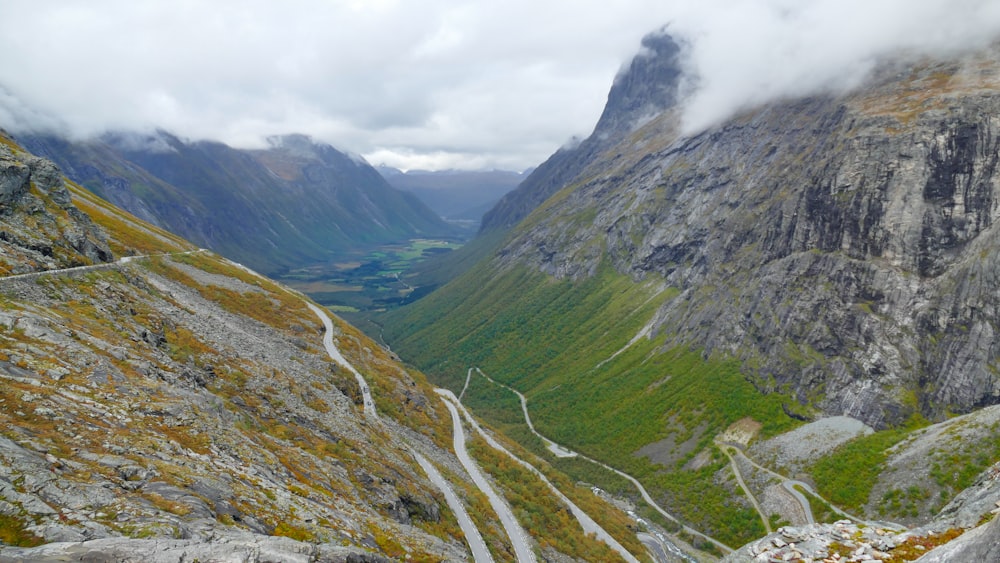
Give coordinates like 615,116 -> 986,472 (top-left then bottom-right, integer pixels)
19,131 -> 455,274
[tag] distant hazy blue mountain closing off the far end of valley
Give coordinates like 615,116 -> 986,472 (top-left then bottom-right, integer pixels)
376,166 -> 525,225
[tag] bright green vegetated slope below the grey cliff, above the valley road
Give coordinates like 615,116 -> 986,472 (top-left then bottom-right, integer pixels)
385,256 -> 795,544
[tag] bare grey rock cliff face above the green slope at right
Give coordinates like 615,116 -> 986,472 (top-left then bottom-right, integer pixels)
500,48 -> 1000,427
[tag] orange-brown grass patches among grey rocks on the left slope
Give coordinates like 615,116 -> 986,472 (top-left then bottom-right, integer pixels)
0,135 -> 672,560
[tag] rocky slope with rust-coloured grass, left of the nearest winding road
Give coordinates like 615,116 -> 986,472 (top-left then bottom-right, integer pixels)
0,135 -> 463,556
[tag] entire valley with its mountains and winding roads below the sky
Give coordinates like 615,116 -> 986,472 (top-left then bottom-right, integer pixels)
0,6 -> 1000,563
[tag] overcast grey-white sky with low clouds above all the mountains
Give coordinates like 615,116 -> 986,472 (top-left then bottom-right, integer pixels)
0,0 -> 1000,170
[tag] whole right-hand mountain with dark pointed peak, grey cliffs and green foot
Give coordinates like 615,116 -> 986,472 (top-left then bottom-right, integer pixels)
380,34 -> 1000,547
